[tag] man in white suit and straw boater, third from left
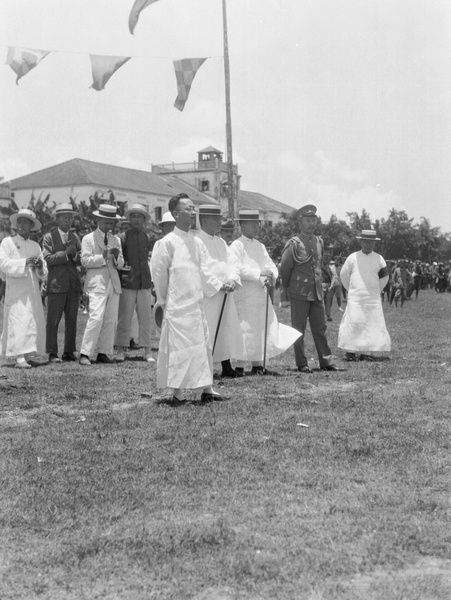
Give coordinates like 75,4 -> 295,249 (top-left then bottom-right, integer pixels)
79,204 -> 124,366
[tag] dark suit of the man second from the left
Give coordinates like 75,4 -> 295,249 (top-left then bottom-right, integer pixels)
42,229 -> 81,354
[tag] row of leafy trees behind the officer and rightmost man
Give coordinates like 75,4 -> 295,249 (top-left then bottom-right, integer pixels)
260,208 -> 451,263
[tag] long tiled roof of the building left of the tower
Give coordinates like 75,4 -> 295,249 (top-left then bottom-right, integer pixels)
9,158 -> 216,204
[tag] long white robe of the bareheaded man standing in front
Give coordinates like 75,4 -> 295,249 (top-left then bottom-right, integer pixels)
151,227 -> 222,389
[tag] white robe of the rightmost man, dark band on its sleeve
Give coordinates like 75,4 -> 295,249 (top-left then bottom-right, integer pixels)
338,250 -> 391,353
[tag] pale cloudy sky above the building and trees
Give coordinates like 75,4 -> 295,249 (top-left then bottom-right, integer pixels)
0,0 -> 451,232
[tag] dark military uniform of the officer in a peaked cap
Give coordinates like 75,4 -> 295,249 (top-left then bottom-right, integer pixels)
279,233 -> 332,367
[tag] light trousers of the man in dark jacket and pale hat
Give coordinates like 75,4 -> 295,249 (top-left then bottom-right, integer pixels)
116,289 -> 152,349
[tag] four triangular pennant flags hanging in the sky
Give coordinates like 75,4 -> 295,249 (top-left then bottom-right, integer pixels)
6,0 -> 215,111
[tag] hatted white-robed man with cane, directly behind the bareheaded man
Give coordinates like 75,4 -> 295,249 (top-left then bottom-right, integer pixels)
196,205 -> 244,379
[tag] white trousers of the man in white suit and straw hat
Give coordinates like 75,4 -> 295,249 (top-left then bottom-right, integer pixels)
80,281 -> 120,357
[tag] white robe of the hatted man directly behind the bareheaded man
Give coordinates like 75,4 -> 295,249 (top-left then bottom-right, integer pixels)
196,230 -> 244,362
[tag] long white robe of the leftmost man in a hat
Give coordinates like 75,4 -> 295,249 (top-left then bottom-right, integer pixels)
0,235 -> 47,357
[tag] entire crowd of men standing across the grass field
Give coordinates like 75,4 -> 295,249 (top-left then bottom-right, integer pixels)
0,194 -> 450,403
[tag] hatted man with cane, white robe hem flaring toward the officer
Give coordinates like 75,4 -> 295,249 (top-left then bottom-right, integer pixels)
230,210 -> 301,375
